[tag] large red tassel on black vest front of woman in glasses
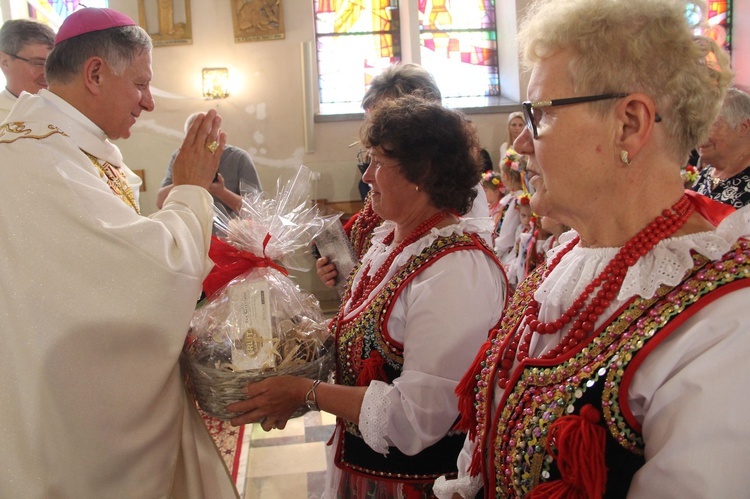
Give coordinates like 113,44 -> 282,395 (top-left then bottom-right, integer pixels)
527,404 -> 607,499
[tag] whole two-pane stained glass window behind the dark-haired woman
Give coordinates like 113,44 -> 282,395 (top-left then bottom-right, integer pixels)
313,0 -> 500,109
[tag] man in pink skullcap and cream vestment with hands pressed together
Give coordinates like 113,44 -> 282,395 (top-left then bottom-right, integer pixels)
0,8 -> 237,499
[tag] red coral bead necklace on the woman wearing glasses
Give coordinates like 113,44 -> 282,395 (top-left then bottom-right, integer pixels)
497,195 -> 694,389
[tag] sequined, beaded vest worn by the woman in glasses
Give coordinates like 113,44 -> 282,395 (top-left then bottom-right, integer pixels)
475,240 -> 750,498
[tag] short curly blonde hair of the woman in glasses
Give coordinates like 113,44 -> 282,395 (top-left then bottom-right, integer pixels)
519,0 -> 732,161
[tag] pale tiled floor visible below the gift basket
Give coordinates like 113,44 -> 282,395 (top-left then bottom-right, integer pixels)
237,412 -> 336,499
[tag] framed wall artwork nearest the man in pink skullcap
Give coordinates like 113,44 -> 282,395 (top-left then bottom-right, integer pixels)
138,0 -> 193,47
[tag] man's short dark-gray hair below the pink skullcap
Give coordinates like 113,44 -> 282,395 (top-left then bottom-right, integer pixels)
45,26 -> 152,83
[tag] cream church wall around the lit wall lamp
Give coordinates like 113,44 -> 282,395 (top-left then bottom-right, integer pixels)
110,0 -> 520,219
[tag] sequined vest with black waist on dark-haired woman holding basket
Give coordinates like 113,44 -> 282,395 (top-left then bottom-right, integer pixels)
331,234 -> 500,484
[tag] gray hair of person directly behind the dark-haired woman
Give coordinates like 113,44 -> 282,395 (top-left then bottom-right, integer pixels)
362,64 -> 442,109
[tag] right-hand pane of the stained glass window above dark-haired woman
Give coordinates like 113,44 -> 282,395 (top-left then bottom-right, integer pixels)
418,0 -> 500,97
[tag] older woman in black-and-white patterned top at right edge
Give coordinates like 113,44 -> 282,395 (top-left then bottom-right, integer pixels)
692,88 -> 750,208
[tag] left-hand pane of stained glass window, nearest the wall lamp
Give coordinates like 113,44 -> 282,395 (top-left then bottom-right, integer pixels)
313,0 -> 401,104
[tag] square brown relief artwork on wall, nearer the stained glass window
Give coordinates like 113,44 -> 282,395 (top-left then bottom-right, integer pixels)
231,0 -> 284,42
